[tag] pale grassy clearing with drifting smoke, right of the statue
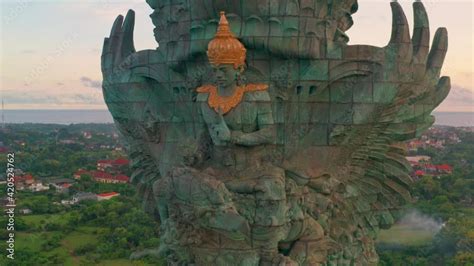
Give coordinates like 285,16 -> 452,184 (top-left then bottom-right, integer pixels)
377,225 -> 434,246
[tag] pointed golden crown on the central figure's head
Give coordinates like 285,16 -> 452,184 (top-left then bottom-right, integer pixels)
207,11 -> 247,69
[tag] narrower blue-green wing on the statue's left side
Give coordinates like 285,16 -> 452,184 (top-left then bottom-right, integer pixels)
102,11 -> 204,214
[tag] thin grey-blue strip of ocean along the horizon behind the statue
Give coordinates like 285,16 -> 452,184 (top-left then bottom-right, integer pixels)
3,110 -> 474,127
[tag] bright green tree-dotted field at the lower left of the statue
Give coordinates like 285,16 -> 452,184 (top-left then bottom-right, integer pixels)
0,194 -> 164,265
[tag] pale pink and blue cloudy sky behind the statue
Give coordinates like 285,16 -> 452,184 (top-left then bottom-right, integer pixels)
0,0 -> 474,112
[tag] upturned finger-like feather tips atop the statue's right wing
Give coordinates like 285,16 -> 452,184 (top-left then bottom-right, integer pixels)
382,2 -> 450,97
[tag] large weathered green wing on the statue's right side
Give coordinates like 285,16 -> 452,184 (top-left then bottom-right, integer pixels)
274,2 -> 450,260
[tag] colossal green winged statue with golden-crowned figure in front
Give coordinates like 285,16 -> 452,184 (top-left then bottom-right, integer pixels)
102,0 -> 450,266
